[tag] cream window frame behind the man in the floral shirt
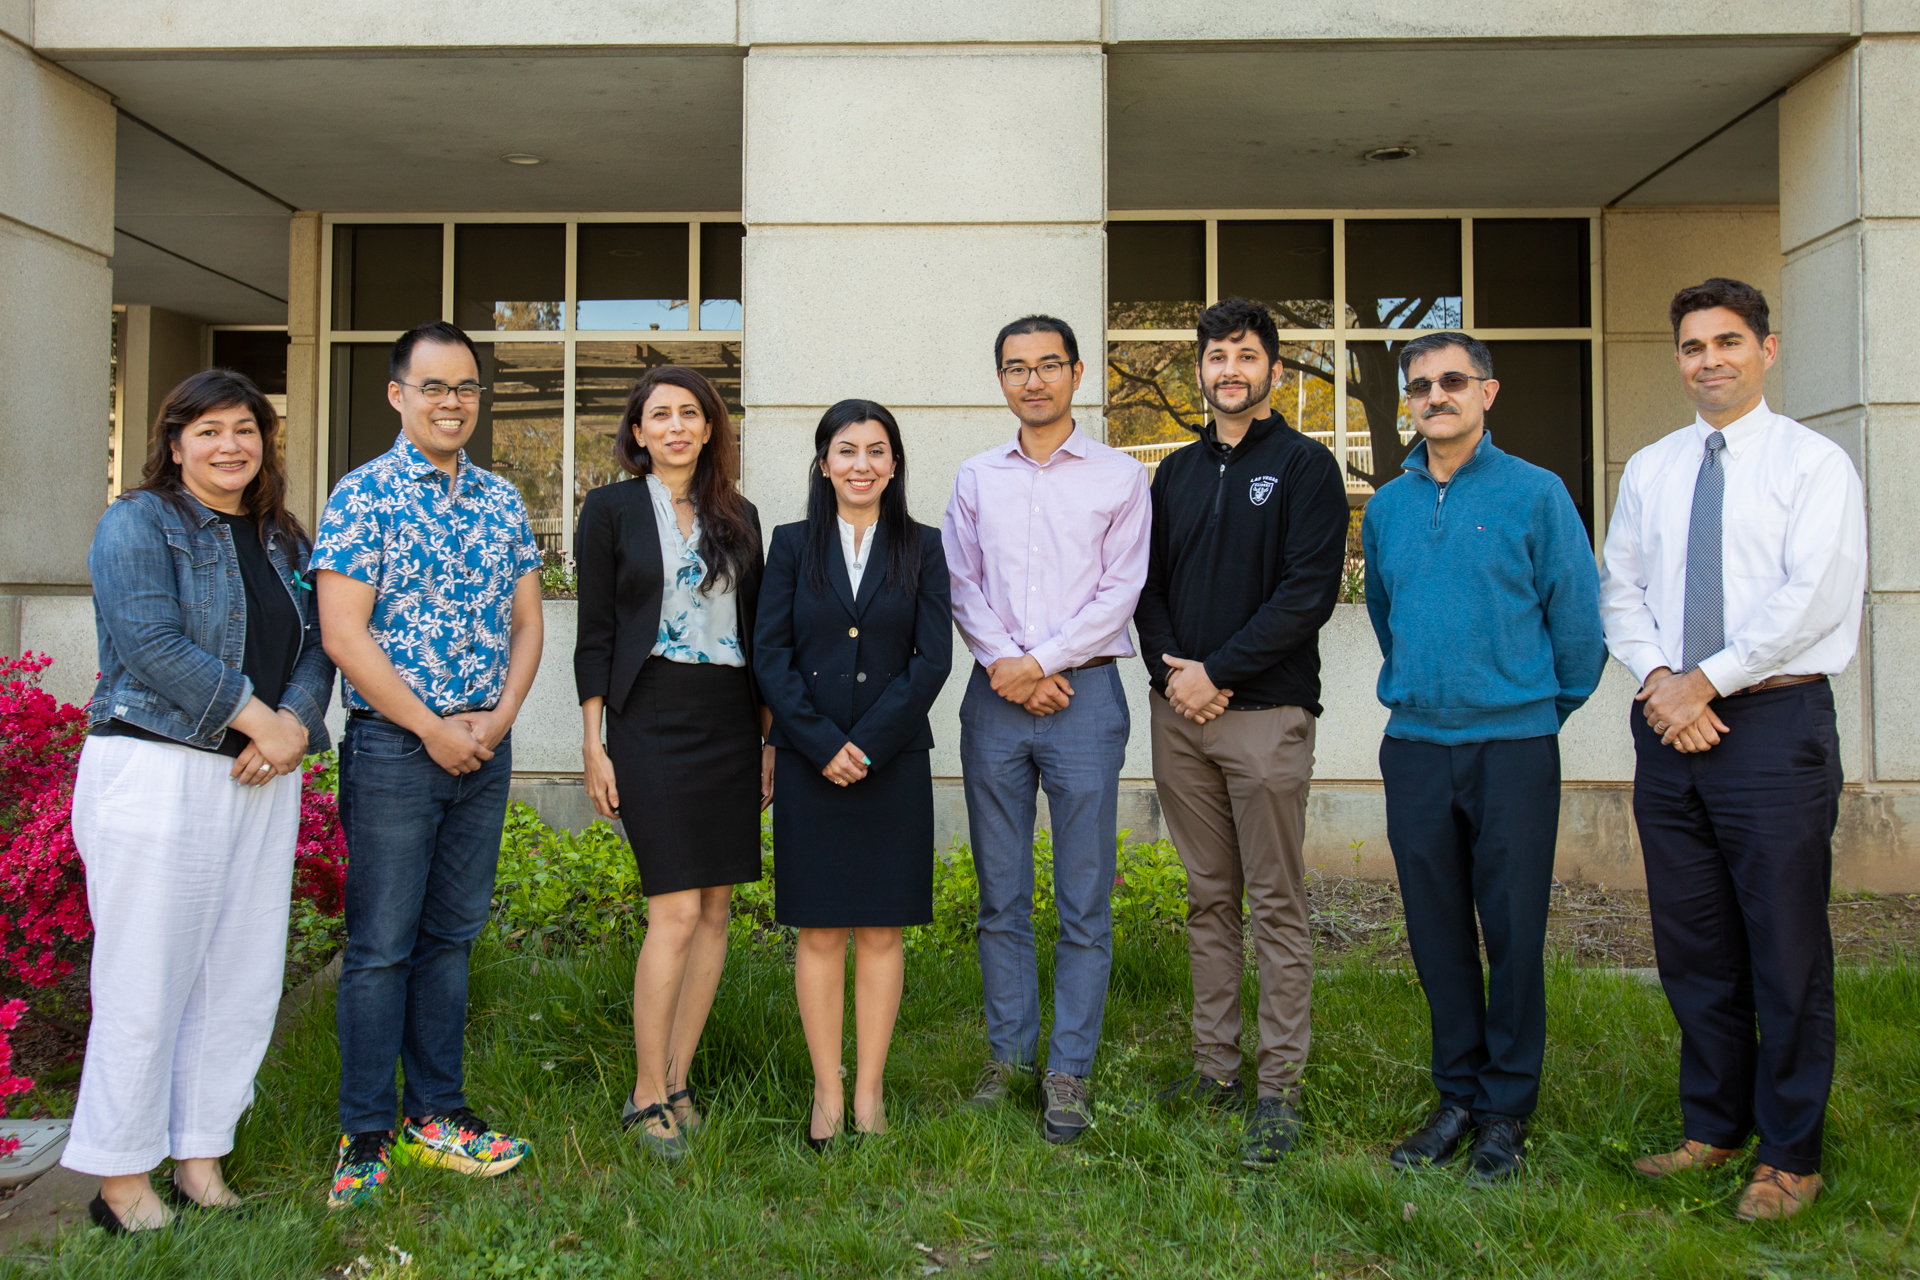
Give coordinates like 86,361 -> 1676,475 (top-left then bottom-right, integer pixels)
313,209 -> 745,557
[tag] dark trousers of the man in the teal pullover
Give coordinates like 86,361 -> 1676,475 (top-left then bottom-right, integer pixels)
1380,735 -> 1559,1123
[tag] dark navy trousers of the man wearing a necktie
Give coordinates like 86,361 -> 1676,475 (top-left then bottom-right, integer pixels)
1630,679 -> 1839,1173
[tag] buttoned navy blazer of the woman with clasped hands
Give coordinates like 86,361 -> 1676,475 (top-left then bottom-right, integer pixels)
753,522 -> 954,770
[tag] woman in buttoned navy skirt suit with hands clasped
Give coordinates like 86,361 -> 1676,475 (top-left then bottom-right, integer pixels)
753,399 -> 952,1150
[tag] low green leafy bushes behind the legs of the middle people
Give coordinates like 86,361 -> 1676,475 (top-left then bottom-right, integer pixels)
493,804 -> 1187,954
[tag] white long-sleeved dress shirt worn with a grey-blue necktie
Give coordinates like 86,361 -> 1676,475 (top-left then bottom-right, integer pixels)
1599,399 -> 1866,697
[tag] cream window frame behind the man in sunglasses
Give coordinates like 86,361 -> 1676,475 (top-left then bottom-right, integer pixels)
1106,209 -> 1609,555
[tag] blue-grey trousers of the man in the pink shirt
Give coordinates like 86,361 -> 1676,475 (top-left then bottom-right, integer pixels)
960,664 -> 1131,1077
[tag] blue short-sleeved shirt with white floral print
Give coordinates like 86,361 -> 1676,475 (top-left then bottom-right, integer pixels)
313,434 -> 540,716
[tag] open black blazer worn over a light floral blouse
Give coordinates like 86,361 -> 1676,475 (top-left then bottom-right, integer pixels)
574,476 -> 764,721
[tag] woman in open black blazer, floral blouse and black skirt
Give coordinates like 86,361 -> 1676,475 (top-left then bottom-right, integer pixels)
574,365 -> 774,1157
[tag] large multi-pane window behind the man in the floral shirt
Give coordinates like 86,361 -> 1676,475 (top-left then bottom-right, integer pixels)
322,213 -> 747,553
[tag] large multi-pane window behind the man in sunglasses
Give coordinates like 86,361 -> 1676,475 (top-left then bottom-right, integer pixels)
1106,213 -> 1601,537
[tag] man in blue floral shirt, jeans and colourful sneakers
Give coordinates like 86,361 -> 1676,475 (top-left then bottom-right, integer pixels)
313,322 -> 541,1209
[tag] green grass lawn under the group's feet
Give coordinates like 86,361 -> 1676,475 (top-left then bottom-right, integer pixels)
15,944 -> 1920,1280
